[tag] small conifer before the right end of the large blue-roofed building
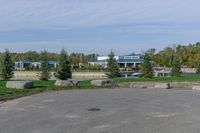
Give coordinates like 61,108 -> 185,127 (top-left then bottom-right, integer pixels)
140,53 -> 154,78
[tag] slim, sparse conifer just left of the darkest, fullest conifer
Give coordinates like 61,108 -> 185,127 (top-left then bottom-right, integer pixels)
39,51 -> 51,81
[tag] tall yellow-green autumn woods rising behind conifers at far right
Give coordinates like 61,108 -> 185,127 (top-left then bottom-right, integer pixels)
152,42 -> 200,68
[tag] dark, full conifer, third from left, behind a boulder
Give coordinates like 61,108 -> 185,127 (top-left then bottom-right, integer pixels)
55,49 -> 72,80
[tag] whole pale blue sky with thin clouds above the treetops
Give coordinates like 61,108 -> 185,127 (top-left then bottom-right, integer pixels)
0,0 -> 200,54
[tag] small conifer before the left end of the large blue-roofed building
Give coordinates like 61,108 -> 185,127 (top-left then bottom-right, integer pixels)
106,52 -> 120,78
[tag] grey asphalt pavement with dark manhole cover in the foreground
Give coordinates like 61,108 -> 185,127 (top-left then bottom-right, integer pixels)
0,89 -> 200,133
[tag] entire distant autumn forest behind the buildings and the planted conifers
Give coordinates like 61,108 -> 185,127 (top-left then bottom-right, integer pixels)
0,42 -> 200,68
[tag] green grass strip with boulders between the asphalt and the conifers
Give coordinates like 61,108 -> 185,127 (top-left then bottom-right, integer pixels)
0,76 -> 200,101
